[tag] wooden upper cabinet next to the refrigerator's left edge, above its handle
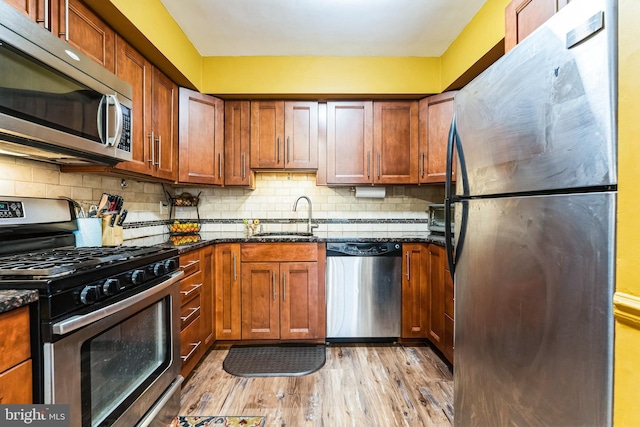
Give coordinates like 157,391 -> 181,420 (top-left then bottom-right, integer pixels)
419,92 -> 457,184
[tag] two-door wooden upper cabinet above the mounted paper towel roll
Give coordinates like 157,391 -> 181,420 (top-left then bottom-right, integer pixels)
326,101 -> 419,185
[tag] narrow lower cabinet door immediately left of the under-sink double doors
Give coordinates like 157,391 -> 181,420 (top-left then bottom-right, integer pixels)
215,244 -> 241,340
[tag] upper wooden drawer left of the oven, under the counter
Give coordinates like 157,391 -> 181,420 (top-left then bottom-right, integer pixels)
0,306 -> 31,372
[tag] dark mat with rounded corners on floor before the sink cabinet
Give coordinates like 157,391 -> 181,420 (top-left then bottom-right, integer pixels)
222,345 -> 326,377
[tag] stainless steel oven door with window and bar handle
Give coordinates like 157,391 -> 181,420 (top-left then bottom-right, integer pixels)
44,271 -> 184,427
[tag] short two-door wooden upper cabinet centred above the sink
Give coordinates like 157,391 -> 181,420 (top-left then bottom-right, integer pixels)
250,101 -> 318,170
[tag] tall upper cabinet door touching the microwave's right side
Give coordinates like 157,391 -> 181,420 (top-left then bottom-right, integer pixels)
115,37 -> 154,175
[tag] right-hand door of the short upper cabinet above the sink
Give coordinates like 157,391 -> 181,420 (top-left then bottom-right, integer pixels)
284,101 -> 318,170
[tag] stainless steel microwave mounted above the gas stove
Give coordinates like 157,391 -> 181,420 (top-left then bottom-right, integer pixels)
0,2 -> 133,164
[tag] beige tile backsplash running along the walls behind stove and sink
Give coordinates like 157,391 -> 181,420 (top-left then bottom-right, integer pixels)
0,155 -> 444,239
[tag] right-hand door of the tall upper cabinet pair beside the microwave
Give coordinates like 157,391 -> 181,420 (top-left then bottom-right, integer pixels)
151,67 -> 178,181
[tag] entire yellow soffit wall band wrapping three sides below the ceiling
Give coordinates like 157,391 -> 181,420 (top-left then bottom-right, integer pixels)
110,0 -> 508,95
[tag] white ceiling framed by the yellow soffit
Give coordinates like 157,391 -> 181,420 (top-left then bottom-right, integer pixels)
160,0 -> 486,56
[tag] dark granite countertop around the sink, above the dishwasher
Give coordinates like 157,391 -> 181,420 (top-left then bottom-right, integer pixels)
124,232 -> 444,254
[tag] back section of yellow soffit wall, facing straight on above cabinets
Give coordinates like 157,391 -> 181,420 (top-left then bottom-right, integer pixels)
201,56 -> 440,95
